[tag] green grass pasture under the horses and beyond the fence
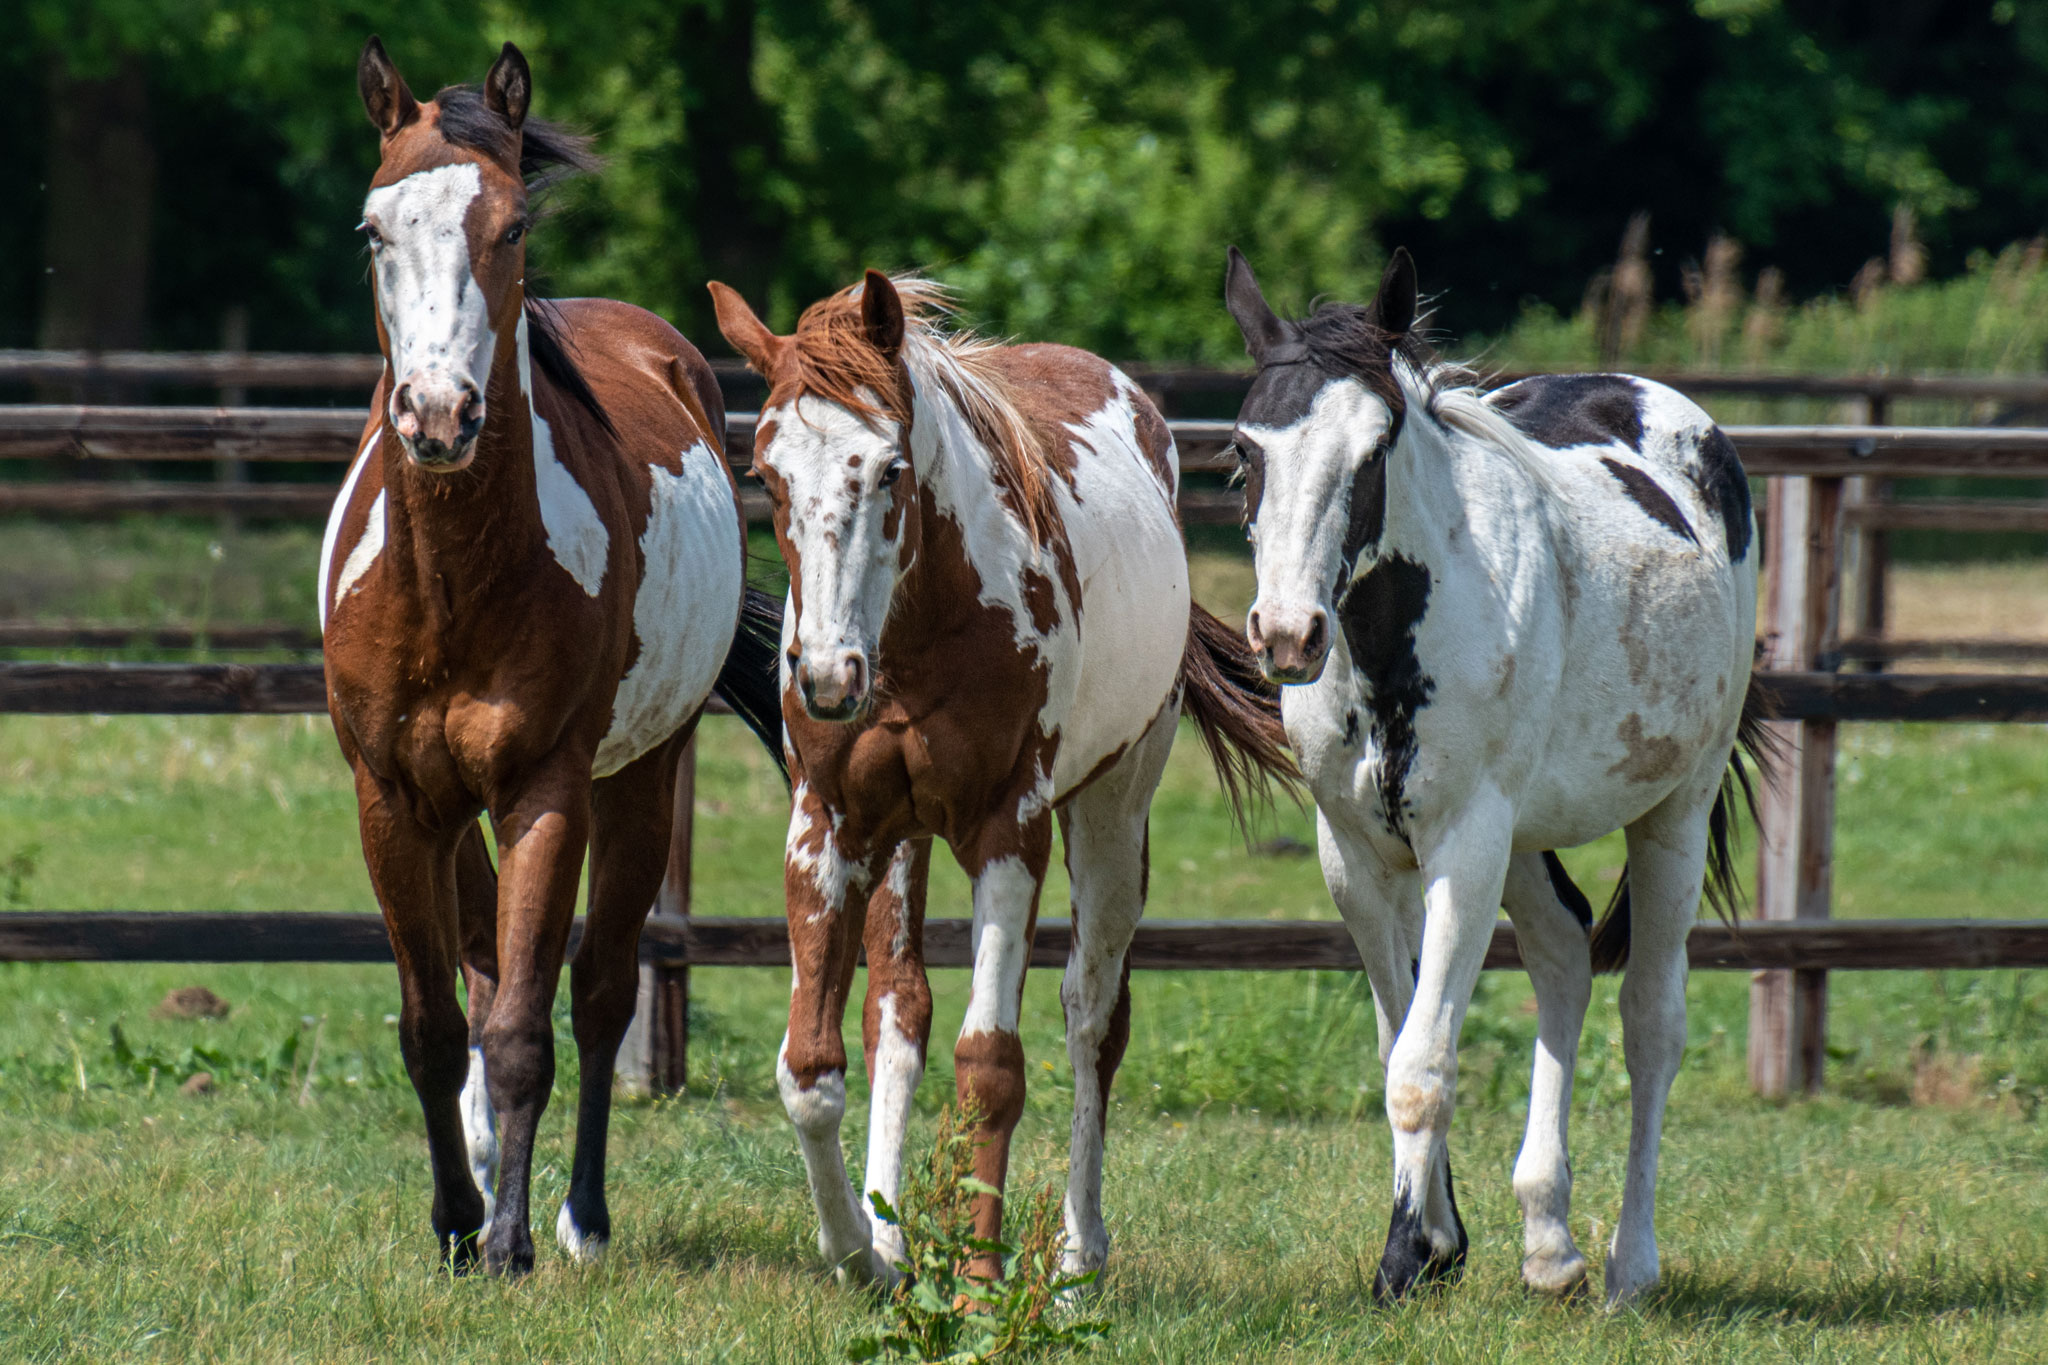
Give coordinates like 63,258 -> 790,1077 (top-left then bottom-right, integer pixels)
0,528 -> 2048,1363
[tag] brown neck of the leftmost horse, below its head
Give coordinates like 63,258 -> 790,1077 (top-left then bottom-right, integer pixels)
383,311 -> 541,602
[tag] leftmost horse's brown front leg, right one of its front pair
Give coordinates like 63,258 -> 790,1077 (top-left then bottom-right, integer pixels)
483,759 -> 590,1275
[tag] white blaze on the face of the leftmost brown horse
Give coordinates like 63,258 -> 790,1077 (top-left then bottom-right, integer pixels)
362,162 -> 498,393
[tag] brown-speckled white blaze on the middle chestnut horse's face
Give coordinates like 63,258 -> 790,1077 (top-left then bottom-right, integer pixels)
760,397 -> 901,659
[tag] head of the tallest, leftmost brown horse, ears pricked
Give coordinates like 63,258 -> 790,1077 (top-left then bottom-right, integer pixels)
356,39 -> 532,473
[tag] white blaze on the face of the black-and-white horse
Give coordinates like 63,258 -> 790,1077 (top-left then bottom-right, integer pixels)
1239,379 -> 1393,616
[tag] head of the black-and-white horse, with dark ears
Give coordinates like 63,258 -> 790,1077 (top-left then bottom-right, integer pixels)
1223,246 -> 1415,684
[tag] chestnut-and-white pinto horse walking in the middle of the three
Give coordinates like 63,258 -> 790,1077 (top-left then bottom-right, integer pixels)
711,270 -> 1294,1279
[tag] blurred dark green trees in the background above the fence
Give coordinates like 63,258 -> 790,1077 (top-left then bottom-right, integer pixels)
0,0 -> 2048,368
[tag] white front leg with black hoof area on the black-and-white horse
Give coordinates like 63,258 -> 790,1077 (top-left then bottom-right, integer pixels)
1372,794 -> 1513,1300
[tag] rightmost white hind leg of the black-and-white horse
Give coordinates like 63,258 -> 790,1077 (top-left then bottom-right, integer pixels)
1608,767 -> 1720,1306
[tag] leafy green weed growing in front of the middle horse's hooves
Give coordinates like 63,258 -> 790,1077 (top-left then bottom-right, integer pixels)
846,1105 -> 1108,1365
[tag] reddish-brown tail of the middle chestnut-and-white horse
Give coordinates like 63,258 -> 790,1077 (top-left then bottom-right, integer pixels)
1180,604 -> 1303,835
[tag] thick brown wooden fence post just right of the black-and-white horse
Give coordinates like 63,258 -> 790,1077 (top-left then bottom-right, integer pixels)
1749,477 -> 1843,1097
